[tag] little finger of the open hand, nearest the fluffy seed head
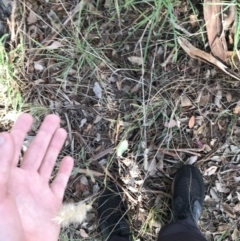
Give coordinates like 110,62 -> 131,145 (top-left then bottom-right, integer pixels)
51,156 -> 73,200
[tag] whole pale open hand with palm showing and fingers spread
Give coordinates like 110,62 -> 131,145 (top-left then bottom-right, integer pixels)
0,114 -> 73,241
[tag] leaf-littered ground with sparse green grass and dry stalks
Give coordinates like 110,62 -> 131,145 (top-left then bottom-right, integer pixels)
0,0 -> 240,241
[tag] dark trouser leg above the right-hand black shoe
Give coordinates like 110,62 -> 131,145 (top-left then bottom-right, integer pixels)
158,217 -> 206,241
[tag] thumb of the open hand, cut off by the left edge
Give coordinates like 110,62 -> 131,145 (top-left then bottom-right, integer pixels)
0,132 -> 14,196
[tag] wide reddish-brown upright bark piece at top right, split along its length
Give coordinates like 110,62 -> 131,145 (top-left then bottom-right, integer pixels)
203,0 -> 229,65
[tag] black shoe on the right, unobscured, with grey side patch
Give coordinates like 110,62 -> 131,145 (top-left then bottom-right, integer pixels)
172,165 -> 205,223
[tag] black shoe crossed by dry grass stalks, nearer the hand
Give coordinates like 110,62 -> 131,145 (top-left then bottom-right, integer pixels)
98,184 -> 130,241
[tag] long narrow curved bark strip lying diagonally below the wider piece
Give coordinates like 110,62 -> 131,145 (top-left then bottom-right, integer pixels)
178,37 -> 240,81
